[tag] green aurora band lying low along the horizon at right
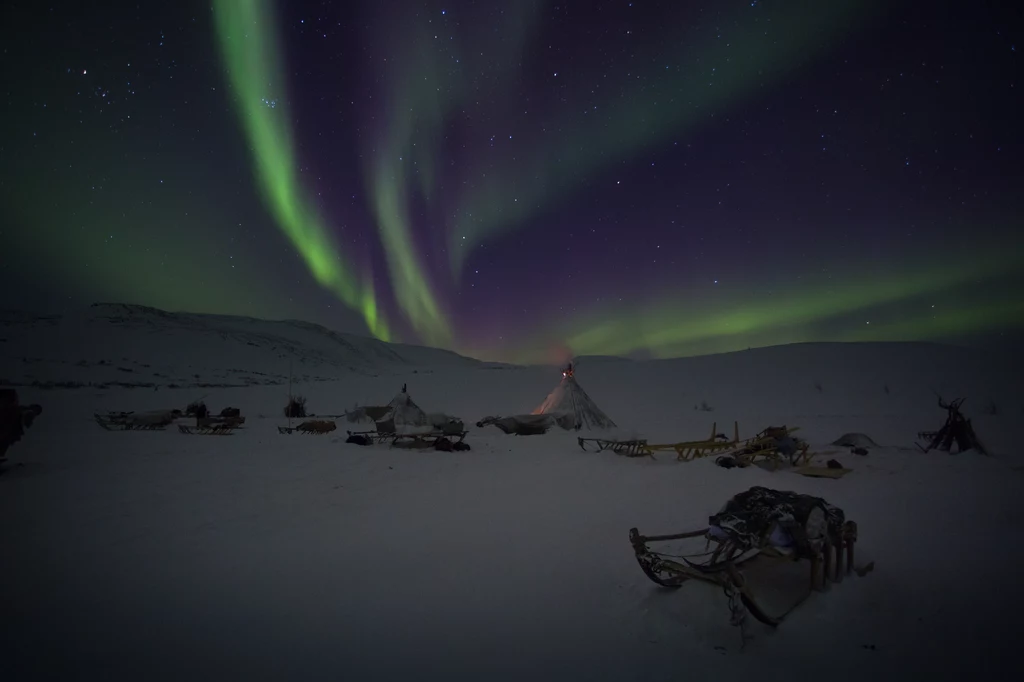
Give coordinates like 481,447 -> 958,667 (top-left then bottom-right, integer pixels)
473,241 -> 1024,363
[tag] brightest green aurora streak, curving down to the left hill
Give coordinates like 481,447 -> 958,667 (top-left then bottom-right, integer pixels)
213,0 -> 391,341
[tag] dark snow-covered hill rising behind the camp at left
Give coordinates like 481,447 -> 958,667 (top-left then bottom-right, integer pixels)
0,303 -> 479,388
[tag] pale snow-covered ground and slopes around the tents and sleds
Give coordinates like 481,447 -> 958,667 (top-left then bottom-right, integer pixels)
0,305 -> 1024,681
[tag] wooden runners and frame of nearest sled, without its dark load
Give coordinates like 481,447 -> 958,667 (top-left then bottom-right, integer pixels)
630,493 -> 873,628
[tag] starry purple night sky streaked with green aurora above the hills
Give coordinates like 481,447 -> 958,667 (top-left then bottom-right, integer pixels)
0,0 -> 1024,360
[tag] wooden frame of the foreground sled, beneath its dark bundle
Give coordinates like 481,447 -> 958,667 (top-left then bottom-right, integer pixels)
630,521 -> 857,628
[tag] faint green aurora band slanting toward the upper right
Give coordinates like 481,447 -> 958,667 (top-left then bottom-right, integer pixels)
449,0 -> 874,270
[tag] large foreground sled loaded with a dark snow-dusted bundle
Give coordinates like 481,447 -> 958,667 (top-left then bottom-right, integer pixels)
630,486 -> 873,640
